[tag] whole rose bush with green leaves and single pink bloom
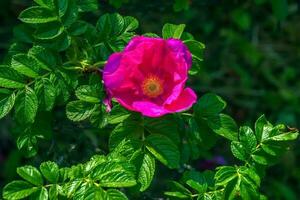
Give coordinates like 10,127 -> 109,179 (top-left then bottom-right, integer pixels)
0,0 -> 298,200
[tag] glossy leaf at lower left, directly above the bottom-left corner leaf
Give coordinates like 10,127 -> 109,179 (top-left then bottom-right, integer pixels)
17,165 -> 43,186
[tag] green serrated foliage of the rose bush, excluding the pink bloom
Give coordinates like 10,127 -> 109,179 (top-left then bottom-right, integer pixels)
0,0 -> 298,199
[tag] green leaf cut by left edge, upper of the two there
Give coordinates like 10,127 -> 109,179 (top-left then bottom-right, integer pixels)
0,65 -> 25,88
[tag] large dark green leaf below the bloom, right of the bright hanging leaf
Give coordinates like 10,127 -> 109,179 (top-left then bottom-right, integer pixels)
146,134 -> 180,169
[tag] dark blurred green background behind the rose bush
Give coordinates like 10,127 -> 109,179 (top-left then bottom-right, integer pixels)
0,0 -> 300,200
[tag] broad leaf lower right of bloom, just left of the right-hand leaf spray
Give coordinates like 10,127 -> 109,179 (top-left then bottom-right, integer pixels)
207,114 -> 238,141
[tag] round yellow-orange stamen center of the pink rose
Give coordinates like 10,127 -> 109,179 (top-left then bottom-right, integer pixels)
142,75 -> 163,98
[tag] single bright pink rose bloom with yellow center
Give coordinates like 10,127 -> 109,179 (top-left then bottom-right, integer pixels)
103,36 -> 197,117
